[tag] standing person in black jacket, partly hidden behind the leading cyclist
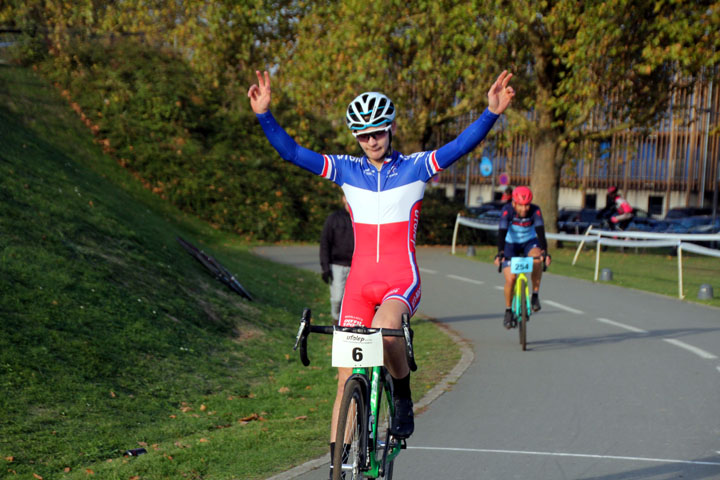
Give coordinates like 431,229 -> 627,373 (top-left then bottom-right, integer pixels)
320,196 -> 355,325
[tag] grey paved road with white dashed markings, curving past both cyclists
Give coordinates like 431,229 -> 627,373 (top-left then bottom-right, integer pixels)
259,247 -> 720,480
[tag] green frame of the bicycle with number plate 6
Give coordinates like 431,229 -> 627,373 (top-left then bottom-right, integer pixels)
353,367 -> 401,478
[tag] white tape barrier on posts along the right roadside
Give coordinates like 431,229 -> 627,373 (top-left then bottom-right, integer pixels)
452,214 -> 720,298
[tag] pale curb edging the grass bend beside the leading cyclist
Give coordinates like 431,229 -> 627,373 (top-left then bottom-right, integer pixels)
266,321 -> 475,480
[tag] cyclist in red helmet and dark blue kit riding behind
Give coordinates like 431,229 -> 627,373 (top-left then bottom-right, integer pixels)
495,186 -> 551,329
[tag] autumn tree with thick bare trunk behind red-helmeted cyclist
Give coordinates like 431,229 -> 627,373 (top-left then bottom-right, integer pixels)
488,0 -> 720,232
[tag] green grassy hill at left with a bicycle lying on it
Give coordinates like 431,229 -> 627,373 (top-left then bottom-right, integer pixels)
0,65 -> 458,479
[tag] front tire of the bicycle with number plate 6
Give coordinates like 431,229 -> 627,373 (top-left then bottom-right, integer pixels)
332,378 -> 367,480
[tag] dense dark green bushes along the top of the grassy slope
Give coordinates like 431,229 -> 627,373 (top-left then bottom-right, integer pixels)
38,38 -> 340,241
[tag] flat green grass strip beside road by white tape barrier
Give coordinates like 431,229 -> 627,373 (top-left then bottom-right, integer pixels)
457,244 -> 720,307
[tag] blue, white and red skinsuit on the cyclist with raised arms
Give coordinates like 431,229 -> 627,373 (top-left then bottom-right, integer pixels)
257,110 -> 498,326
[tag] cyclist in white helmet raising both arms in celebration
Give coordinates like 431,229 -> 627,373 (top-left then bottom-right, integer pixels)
248,67 -> 515,474
